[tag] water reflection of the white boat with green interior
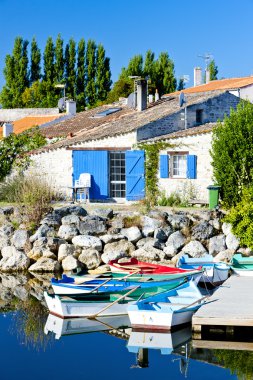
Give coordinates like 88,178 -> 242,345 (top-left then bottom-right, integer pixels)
44,314 -> 130,339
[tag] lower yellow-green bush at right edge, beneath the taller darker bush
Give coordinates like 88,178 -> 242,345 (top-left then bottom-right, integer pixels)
224,185 -> 253,249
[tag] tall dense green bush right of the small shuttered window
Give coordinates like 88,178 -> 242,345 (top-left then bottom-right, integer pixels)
211,101 -> 253,207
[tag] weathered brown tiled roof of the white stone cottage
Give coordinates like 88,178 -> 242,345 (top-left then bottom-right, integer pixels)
31,91 -> 223,154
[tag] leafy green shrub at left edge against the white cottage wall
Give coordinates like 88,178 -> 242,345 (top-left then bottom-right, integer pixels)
0,128 -> 46,180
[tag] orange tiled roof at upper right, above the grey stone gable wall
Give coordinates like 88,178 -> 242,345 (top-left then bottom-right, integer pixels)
163,76 -> 253,97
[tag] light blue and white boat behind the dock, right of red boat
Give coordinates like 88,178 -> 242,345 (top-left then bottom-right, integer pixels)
177,255 -> 230,286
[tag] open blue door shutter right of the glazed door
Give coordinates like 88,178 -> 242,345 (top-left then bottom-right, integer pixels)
126,150 -> 145,201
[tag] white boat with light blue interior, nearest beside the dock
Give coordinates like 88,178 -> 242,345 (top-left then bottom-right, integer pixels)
127,281 -> 206,330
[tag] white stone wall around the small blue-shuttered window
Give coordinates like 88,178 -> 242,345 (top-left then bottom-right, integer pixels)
159,133 -> 213,202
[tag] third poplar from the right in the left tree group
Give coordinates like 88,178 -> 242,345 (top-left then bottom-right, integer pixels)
76,38 -> 86,111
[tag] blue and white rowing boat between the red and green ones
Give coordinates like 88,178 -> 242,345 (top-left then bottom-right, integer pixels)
51,275 -> 190,295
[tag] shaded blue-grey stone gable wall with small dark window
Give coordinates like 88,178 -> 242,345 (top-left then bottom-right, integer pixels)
137,92 -> 240,141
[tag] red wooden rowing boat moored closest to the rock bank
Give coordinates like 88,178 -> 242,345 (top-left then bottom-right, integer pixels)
108,257 -> 201,278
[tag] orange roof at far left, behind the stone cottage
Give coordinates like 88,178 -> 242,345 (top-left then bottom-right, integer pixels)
0,114 -> 62,137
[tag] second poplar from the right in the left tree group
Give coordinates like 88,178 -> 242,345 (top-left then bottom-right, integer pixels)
85,40 -> 97,106
